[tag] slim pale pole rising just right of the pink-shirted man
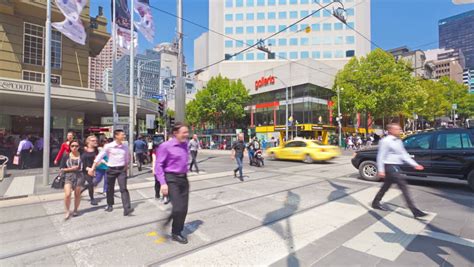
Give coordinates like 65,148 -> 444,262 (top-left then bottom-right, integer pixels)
128,1 -> 135,177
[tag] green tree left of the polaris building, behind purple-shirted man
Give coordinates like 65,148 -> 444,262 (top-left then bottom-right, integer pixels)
186,75 -> 250,128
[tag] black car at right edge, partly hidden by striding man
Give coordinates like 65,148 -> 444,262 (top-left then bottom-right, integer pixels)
352,128 -> 474,190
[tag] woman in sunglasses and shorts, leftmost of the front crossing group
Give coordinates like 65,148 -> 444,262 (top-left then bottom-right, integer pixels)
61,140 -> 84,220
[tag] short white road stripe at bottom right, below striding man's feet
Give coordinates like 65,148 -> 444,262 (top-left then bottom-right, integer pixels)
343,208 -> 436,261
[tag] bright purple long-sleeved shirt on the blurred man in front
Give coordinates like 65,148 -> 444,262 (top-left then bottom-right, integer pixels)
155,138 -> 188,185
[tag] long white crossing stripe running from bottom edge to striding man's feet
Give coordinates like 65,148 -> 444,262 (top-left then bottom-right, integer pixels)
164,187 -> 400,266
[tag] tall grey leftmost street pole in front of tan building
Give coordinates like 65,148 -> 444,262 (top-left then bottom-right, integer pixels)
43,0 -> 51,185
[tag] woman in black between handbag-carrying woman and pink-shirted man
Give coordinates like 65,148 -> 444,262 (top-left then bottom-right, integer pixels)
81,135 -> 99,206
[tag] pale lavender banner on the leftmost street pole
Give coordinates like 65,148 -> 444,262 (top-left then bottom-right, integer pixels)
51,0 -> 87,45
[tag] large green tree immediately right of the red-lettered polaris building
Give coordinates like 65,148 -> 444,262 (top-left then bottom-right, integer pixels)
333,49 -> 416,133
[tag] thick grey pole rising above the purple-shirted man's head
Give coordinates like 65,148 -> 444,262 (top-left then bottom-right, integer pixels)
174,0 -> 186,122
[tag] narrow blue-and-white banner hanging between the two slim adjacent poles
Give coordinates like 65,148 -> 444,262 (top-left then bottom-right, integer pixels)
112,0 -> 138,54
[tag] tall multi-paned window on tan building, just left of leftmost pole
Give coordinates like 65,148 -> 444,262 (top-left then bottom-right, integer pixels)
23,23 -> 43,66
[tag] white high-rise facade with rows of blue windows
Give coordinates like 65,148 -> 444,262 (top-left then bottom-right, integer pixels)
194,0 -> 371,80
